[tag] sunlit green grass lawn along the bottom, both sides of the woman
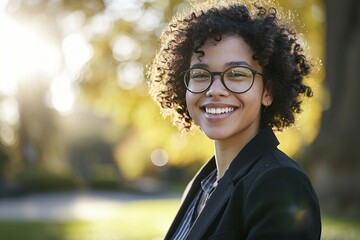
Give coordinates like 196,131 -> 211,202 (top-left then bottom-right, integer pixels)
0,200 -> 360,240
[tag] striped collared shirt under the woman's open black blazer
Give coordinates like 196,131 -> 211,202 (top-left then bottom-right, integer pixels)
172,169 -> 217,240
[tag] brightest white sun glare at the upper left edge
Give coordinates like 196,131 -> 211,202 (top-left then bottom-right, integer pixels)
0,13 -> 61,95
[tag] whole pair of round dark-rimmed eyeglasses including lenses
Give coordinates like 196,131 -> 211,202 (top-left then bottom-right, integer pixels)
183,66 -> 263,93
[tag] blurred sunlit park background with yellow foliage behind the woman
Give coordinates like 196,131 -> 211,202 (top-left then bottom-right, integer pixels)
0,0 -> 360,240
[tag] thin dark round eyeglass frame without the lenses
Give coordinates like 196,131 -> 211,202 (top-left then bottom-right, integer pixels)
182,66 -> 264,94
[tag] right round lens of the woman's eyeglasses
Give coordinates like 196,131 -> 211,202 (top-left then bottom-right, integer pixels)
224,67 -> 254,93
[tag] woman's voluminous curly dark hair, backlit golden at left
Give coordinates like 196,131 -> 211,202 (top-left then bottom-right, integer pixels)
148,0 -> 313,131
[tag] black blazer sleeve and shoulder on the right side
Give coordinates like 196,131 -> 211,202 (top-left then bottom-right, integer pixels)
236,150 -> 321,239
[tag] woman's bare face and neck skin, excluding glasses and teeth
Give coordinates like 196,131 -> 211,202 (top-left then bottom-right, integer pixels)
186,35 -> 273,178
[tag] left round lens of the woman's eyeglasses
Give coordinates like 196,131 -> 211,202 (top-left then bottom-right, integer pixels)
184,68 -> 211,93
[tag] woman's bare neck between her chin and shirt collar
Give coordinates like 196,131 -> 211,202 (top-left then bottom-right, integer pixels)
214,127 -> 258,178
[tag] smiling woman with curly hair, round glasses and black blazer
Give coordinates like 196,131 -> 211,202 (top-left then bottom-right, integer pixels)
149,0 -> 321,240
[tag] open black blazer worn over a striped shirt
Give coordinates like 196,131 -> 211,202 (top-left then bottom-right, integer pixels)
165,128 -> 321,240
